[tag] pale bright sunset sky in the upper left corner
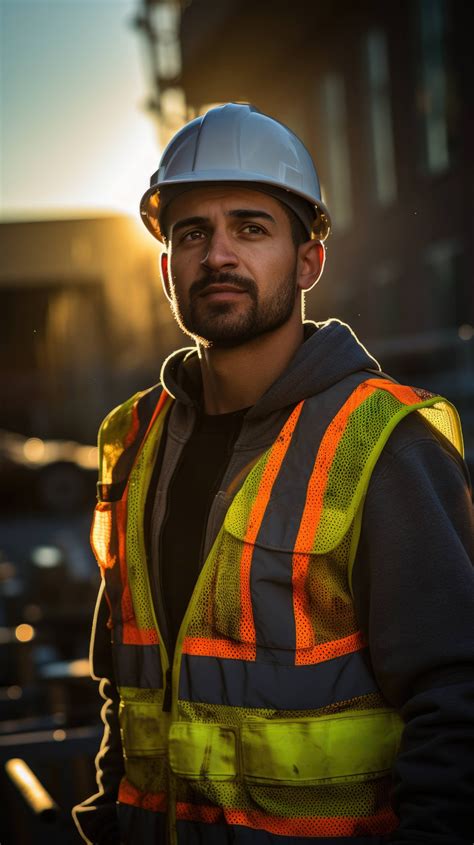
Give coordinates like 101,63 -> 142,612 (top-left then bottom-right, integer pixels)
0,0 -> 159,220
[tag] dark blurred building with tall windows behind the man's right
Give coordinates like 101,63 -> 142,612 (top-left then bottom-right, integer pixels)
134,0 -> 474,450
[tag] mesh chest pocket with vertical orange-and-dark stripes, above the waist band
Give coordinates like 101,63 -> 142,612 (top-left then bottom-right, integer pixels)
200,504 -> 359,664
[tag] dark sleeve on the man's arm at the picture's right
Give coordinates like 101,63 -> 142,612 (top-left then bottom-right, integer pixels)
353,415 -> 474,845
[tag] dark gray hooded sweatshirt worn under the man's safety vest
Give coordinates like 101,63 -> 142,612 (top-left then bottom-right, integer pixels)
75,320 -> 474,845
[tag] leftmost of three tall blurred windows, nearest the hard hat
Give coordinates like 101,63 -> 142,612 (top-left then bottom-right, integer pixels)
322,73 -> 352,231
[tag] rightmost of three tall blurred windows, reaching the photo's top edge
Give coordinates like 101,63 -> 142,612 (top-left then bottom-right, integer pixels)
419,0 -> 450,173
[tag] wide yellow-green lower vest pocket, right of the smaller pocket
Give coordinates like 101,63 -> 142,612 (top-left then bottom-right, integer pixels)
241,710 -> 401,842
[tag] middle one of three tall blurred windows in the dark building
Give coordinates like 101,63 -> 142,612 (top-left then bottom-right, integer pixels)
367,29 -> 397,205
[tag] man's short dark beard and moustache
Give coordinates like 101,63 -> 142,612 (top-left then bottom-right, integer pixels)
172,263 -> 297,349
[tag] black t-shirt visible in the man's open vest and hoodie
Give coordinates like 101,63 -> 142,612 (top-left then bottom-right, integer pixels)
159,408 -> 248,658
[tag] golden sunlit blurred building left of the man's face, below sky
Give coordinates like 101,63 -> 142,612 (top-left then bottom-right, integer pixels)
0,216 -> 183,442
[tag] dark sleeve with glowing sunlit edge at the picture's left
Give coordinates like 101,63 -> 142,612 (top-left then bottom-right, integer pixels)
73,587 -> 124,845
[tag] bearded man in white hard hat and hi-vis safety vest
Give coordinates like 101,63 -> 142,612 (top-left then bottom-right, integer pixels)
75,104 -> 474,845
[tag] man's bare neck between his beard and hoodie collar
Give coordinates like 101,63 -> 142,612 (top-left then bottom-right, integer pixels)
199,321 -> 303,414
